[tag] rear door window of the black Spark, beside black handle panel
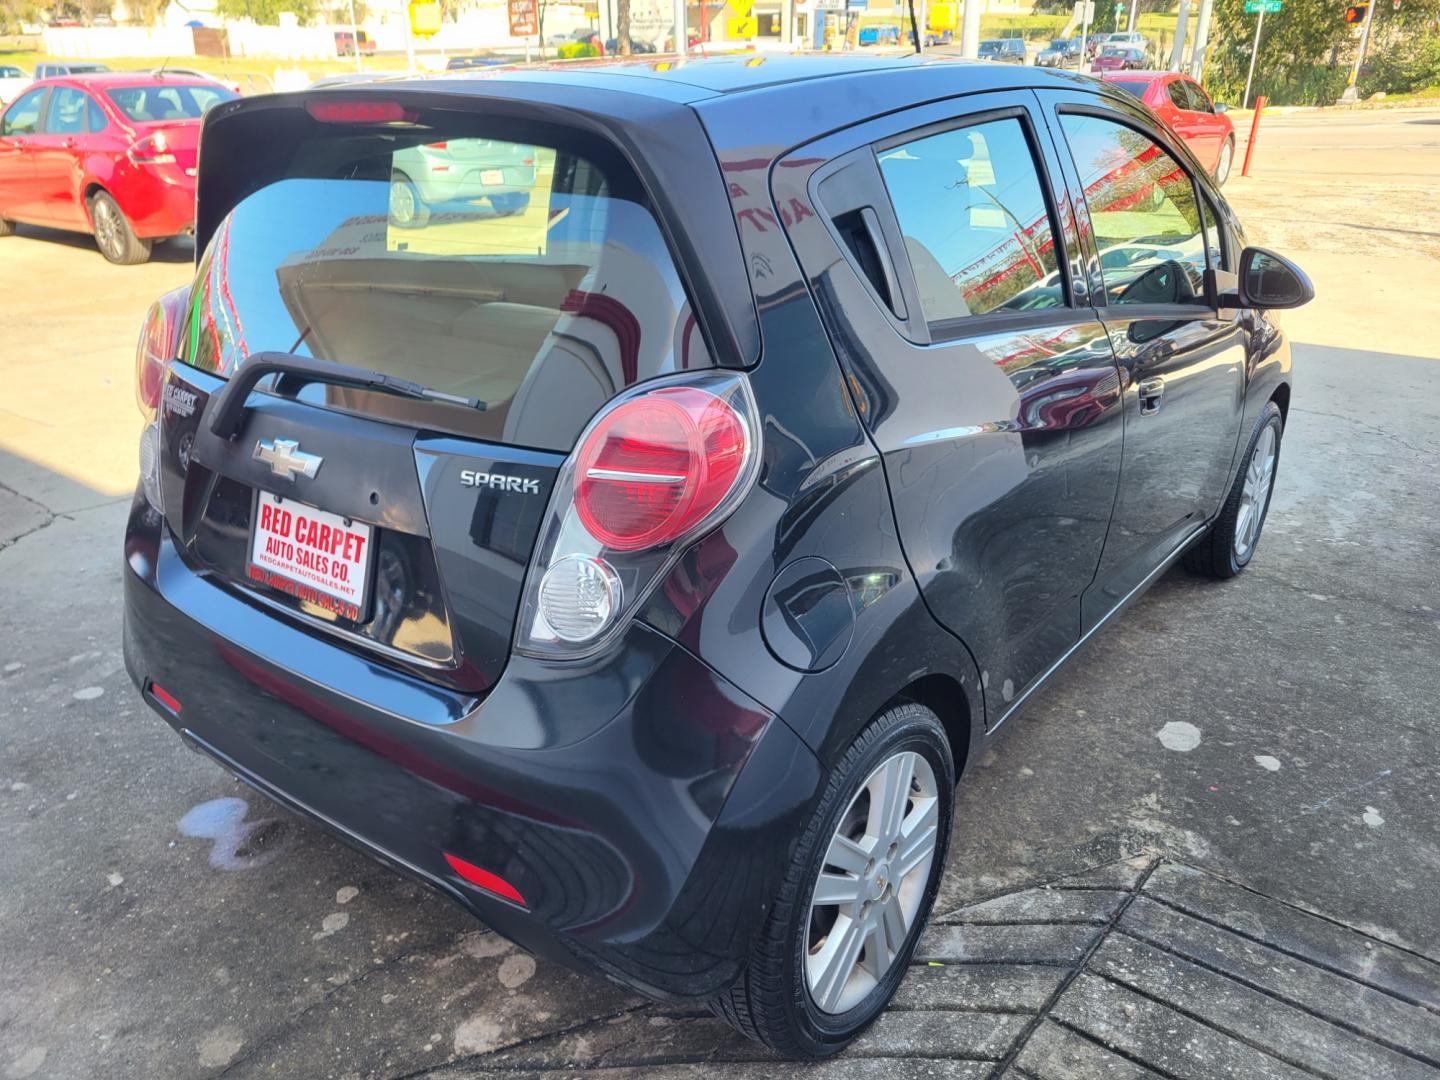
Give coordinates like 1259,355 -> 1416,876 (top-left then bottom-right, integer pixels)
878,117 -> 1066,324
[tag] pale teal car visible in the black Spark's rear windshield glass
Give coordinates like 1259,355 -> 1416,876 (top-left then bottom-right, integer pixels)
390,138 -> 536,226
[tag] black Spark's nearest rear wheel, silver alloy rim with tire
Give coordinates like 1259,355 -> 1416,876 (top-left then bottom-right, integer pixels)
711,704 -> 955,1058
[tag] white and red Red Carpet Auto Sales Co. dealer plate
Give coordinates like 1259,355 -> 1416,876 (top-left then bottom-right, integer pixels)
246,491 -> 374,622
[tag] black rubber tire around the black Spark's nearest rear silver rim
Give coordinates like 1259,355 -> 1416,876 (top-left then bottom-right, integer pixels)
710,703 -> 955,1058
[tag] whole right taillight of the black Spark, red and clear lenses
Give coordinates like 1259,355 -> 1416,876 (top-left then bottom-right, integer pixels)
516,373 -> 760,657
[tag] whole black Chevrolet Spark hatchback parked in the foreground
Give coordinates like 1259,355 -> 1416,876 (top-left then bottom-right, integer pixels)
125,56 -> 1310,1056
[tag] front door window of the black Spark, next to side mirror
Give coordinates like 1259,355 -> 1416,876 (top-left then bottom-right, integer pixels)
1061,114 -> 1207,305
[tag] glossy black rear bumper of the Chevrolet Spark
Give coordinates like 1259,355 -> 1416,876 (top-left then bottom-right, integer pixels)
124,497 -> 822,999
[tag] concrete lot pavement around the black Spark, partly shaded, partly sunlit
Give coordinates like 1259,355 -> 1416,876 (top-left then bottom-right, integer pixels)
8,103 -> 1440,1080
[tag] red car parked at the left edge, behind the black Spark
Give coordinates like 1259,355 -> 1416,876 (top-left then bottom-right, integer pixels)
0,73 -> 236,264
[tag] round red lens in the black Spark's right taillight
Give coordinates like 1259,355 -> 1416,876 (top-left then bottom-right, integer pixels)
575,386 -> 749,552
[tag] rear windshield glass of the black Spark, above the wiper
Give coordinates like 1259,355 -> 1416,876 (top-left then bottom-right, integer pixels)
181,117 -> 711,451
